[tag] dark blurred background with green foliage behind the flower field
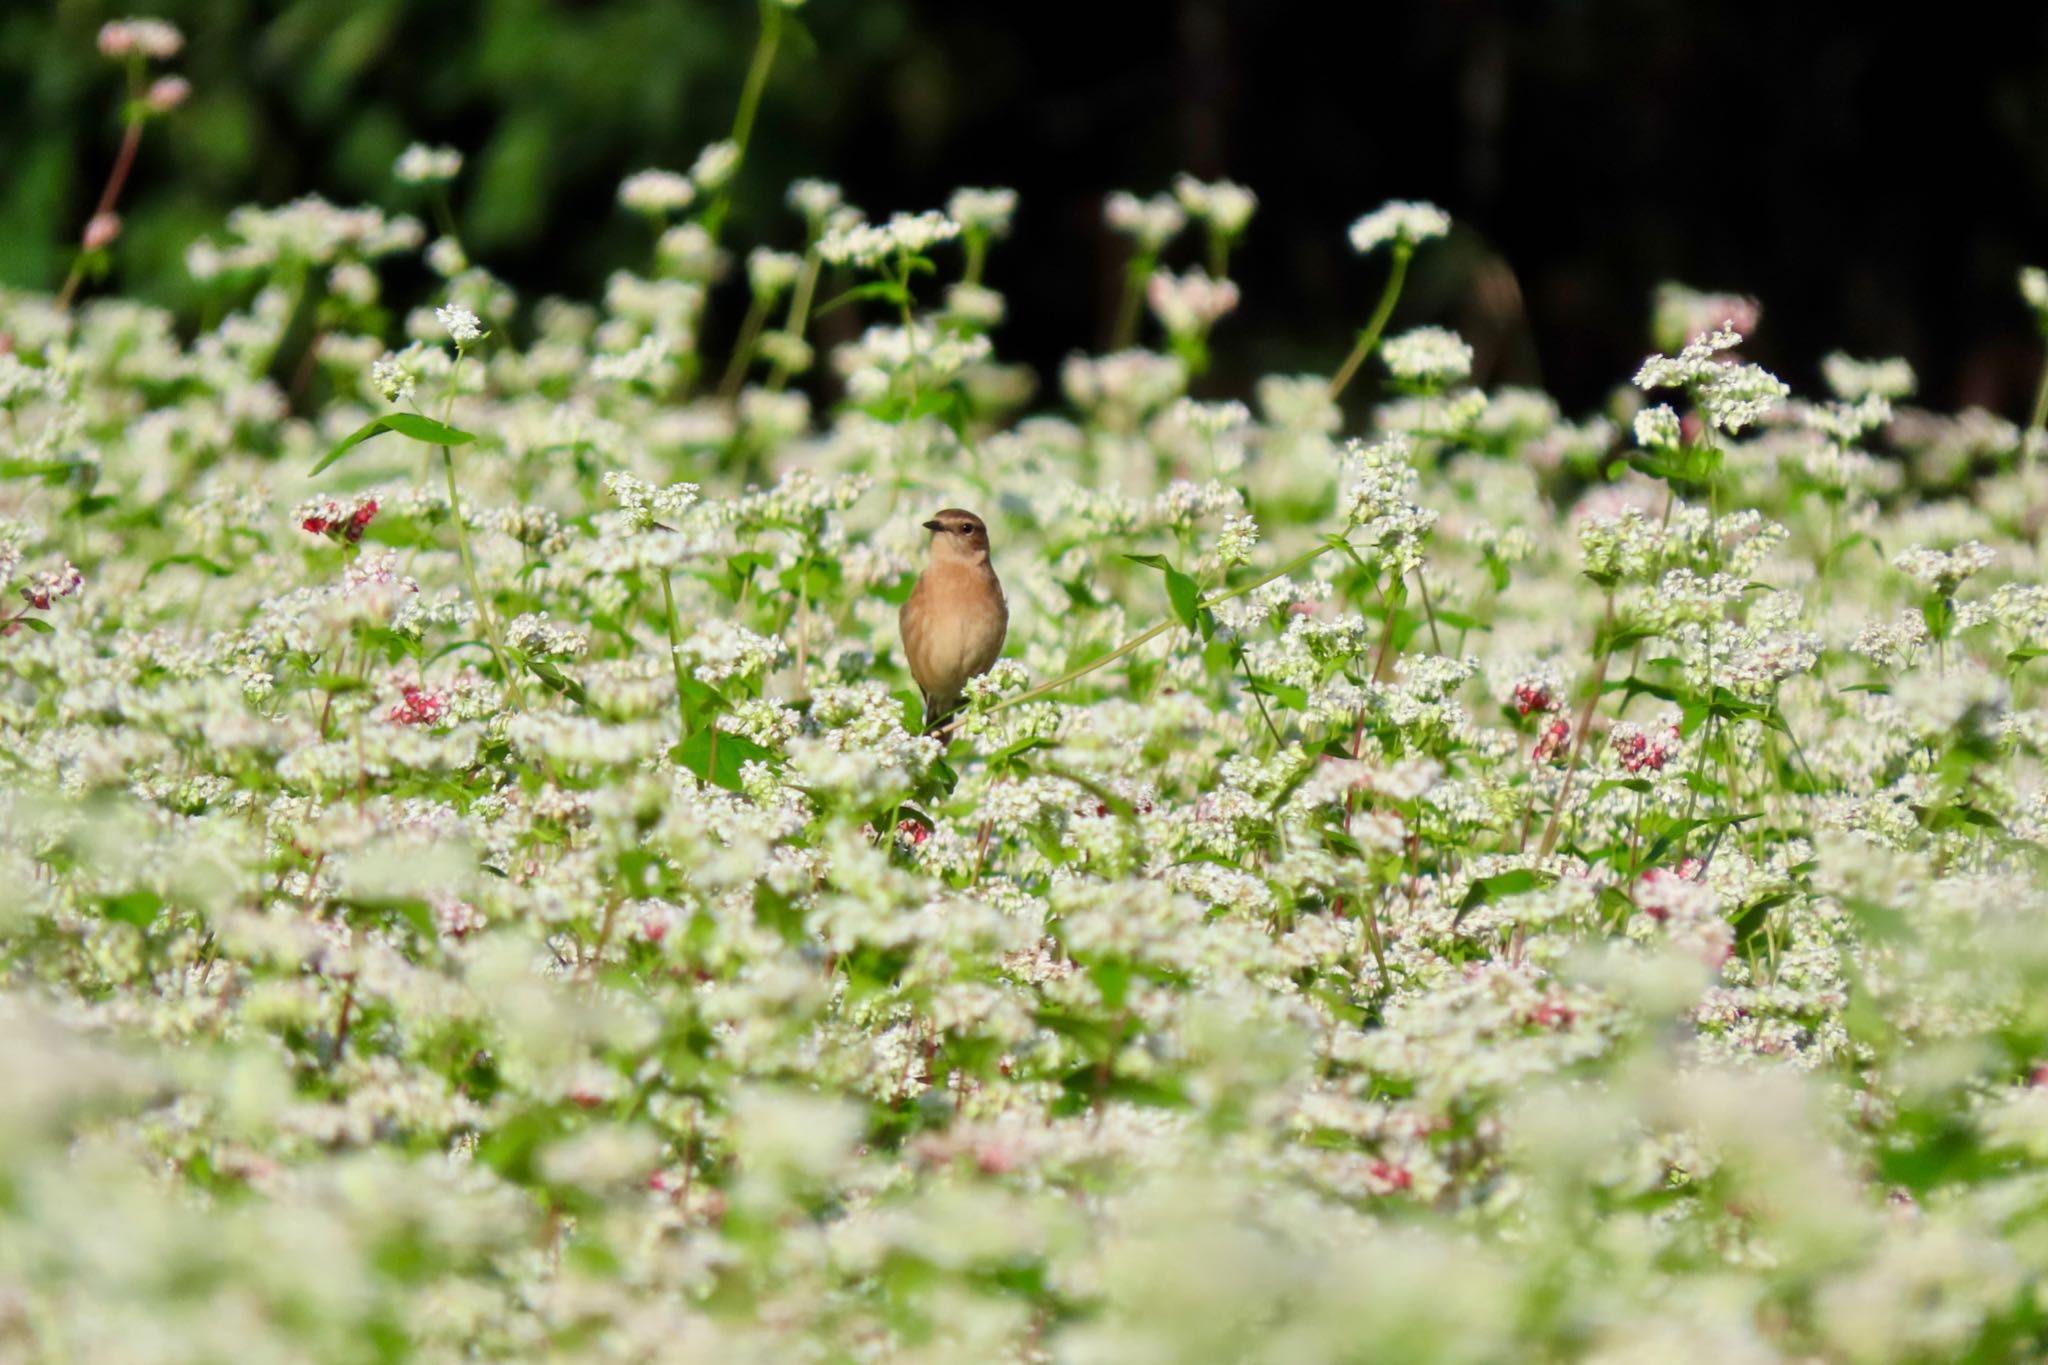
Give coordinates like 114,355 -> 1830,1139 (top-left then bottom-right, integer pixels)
0,0 -> 2048,417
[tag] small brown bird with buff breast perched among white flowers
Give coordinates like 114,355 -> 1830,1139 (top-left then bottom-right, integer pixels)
897,508 -> 1010,731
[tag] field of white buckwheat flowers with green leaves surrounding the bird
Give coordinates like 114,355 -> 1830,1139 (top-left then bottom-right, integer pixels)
0,10 -> 2048,1365
